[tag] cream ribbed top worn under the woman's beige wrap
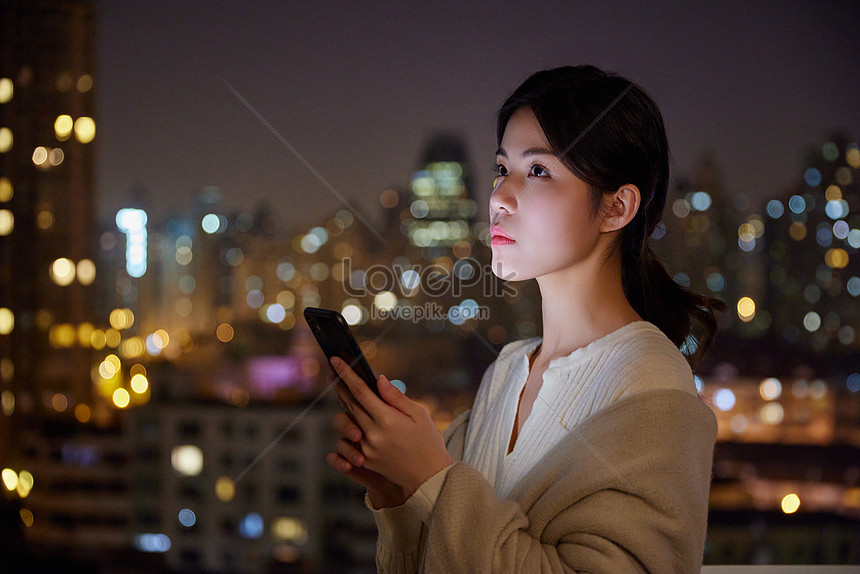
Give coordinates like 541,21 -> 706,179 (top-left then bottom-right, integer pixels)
463,321 -> 696,498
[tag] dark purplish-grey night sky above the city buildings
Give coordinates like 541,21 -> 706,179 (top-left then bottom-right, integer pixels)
95,0 -> 860,232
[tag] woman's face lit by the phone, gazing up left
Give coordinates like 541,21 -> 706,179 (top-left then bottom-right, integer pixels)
490,107 -> 601,281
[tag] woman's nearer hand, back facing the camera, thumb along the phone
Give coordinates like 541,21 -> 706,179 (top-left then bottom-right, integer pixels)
329,358 -> 453,496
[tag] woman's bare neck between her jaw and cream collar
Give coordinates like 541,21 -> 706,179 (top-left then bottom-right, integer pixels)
536,255 -> 641,363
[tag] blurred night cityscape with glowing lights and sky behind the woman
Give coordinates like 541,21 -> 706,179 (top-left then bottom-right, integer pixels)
5,0 -> 860,574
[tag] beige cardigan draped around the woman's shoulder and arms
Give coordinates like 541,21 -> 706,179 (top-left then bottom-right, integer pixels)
375,390 -> 717,574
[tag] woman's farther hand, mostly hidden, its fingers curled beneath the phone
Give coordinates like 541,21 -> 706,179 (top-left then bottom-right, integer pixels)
325,413 -> 409,508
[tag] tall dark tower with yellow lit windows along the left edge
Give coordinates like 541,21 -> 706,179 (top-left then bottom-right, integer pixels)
0,0 -> 98,452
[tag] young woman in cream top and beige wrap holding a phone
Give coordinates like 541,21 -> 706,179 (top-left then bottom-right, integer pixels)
326,66 -> 721,573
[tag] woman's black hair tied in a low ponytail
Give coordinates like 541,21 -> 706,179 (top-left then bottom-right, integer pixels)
496,66 -> 725,365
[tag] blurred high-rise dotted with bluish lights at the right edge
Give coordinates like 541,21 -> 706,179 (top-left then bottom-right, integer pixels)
766,136 -> 860,356
